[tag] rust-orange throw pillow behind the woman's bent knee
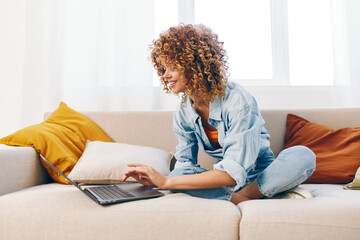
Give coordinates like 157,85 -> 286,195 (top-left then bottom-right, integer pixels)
285,114 -> 360,183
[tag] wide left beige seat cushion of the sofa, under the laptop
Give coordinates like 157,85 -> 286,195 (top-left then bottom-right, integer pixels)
0,183 -> 240,240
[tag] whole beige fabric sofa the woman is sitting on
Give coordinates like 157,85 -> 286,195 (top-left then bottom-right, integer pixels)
0,109 -> 360,240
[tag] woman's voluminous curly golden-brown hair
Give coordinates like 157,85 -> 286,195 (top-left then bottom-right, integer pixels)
150,23 -> 228,108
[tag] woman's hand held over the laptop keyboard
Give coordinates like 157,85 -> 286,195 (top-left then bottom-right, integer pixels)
121,164 -> 168,189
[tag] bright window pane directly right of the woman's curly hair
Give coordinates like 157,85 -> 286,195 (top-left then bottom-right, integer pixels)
195,0 -> 273,79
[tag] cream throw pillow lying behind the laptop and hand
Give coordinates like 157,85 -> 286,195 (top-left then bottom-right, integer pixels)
69,141 -> 172,184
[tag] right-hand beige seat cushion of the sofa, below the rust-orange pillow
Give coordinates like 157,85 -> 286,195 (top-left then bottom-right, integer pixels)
238,184 -> 360,240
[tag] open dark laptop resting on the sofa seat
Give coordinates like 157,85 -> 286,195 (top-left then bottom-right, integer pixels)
40,154 -> 164,205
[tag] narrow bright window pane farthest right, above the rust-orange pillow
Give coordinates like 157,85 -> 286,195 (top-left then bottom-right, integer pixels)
288,0 -> 334,85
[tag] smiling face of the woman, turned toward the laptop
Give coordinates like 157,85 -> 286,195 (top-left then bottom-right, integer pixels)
163,66 -> 189,94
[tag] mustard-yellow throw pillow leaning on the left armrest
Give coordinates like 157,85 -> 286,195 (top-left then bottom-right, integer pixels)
0,102 -> 113,184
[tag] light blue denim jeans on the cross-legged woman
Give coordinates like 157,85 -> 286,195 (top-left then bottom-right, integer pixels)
169,146 -> 316,200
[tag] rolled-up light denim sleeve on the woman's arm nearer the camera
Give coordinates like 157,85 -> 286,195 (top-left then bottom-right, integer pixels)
214,107 -> 264,191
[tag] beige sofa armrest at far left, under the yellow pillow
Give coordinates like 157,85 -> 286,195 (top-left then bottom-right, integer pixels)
0,144 -> 50,196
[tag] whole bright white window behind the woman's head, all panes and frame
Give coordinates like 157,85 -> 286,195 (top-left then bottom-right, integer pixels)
154,0 -> 334,86
